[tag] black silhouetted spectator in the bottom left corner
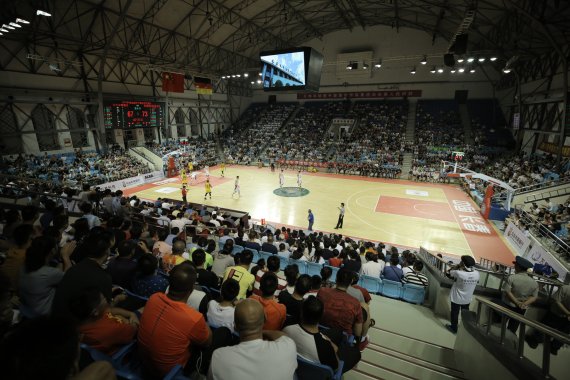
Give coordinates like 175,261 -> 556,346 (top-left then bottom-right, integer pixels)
0,317 -> 115,380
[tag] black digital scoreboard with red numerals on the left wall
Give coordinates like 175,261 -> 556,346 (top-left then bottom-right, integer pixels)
104,101 -> 164,129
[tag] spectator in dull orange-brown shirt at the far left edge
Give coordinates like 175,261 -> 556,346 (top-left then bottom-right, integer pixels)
0,224 -> 34,294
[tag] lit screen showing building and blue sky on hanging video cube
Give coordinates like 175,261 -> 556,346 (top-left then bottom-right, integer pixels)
260,50 -> 305,89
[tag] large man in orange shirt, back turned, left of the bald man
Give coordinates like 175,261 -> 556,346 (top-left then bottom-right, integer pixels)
137,265 -> 212,377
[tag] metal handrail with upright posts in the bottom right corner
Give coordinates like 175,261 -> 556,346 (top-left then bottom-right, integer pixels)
475,296 -> 570,378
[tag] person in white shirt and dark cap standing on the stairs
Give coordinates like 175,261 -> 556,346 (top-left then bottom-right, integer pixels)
445,255 -> 479,334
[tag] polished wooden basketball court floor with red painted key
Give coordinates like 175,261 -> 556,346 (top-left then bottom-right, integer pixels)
127,166 -> 514,263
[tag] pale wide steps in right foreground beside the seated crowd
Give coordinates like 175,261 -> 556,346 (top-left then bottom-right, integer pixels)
343,296 -> 464,380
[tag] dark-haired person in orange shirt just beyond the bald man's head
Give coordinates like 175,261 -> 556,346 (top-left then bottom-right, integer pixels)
250,272 -> 287,330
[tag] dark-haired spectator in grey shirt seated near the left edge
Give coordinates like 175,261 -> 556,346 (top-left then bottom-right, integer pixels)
20,236 -> 75,316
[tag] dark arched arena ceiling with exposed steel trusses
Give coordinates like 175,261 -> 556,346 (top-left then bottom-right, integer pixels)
0,0 -> 570,79
